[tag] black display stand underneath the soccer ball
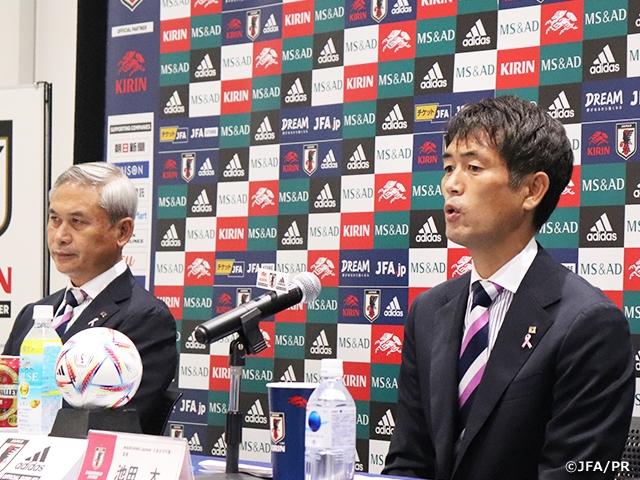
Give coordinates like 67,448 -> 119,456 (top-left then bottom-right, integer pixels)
49,408 -> 142,438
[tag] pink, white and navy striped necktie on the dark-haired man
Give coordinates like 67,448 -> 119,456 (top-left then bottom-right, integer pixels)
458,280 -> 503,432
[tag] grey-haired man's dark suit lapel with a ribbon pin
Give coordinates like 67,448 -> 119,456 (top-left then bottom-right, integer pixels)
62,270 -> 132,341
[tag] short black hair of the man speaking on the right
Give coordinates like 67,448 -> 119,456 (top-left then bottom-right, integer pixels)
444,95 -> 573,231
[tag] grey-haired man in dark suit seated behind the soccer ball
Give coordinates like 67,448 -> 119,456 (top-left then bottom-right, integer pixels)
3,162 -> 178,431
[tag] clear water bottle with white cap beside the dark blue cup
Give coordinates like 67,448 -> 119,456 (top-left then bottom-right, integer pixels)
305,358 -> 356,480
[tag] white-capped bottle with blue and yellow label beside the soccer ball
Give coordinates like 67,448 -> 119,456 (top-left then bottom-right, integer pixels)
18,305 -> 62,435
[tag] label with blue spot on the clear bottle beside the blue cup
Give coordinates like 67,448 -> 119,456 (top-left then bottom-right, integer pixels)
305,407 -> 356,448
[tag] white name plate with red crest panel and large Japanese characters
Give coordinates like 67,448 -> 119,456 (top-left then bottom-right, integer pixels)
78,430 -> 193,480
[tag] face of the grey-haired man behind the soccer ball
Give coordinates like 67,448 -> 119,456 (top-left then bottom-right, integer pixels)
47,183 -> 131,286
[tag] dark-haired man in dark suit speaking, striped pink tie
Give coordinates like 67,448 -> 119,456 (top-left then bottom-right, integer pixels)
383,96 -> 634,480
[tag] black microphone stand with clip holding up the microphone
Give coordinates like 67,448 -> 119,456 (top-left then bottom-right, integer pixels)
204,308 -> 267,480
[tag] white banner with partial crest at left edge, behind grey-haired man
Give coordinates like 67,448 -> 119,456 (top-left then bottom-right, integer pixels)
0,83 -> 51,345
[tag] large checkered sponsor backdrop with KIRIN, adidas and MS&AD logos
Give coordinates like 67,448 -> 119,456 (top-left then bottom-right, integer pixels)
106,0 -> 640,473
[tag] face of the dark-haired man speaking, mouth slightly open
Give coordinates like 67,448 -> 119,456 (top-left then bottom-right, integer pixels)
442,137 -> 534,254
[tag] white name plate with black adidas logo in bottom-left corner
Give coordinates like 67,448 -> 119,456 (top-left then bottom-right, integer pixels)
0,434 -> 87,480
